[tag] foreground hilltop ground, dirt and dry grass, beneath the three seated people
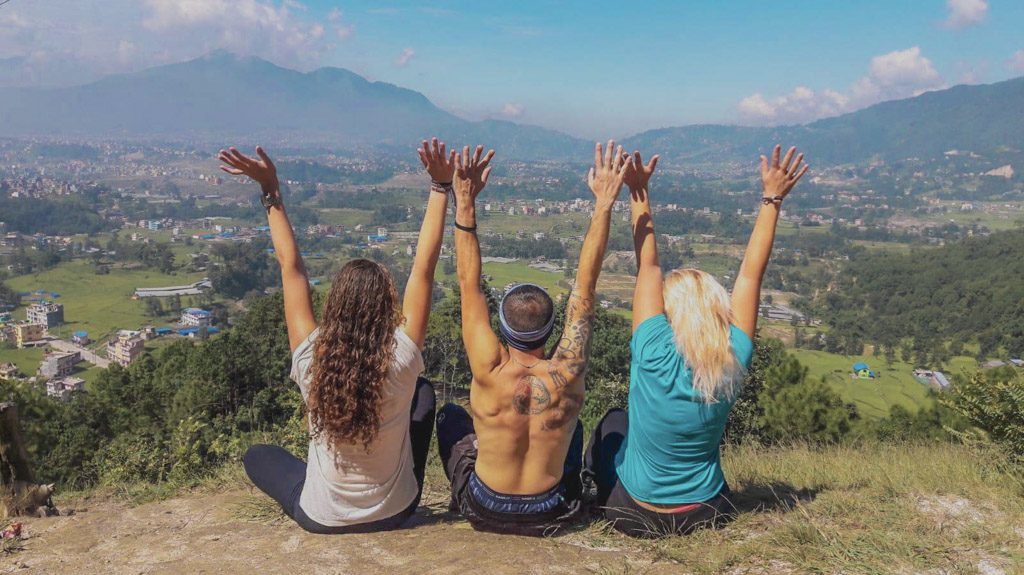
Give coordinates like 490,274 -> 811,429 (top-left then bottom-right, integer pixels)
36,444 -> 1024,575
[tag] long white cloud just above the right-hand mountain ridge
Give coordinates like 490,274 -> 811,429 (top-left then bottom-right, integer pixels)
737,46 -> 944,125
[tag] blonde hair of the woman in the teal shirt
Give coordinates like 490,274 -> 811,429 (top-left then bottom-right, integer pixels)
665,269 -> 745,403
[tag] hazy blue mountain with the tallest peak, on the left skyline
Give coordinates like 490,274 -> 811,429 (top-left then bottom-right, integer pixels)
0,52 -> 582,157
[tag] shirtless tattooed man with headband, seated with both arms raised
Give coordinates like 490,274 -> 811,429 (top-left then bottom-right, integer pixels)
437,141 -> 630,535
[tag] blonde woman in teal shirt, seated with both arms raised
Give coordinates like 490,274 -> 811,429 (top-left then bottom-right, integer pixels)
585,146 -> 807,537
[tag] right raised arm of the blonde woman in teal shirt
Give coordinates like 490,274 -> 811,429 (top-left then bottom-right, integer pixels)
732,145 -> 808,340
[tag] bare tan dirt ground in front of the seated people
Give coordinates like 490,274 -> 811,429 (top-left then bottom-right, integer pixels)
0,490 -> 684,575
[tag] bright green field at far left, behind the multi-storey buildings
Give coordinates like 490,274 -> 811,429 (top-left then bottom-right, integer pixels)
6,261 -> 203,341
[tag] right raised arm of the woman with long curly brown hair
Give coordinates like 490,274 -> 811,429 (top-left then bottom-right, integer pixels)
401,138 -> 455,349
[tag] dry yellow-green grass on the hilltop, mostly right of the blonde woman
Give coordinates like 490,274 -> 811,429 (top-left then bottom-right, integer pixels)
64,444 -> 1024,575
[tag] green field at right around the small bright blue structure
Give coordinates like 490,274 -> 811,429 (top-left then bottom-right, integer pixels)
790,349 -> 975,418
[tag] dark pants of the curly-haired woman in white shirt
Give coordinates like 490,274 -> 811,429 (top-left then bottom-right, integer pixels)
243,378 -> 437,534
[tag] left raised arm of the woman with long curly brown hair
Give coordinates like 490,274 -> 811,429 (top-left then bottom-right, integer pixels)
219,146 -> 316,351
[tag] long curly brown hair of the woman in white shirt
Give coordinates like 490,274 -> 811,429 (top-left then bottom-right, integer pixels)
307,260 -> 402,450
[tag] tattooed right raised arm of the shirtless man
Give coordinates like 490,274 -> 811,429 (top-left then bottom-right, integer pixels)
550,141 -> 631,389
